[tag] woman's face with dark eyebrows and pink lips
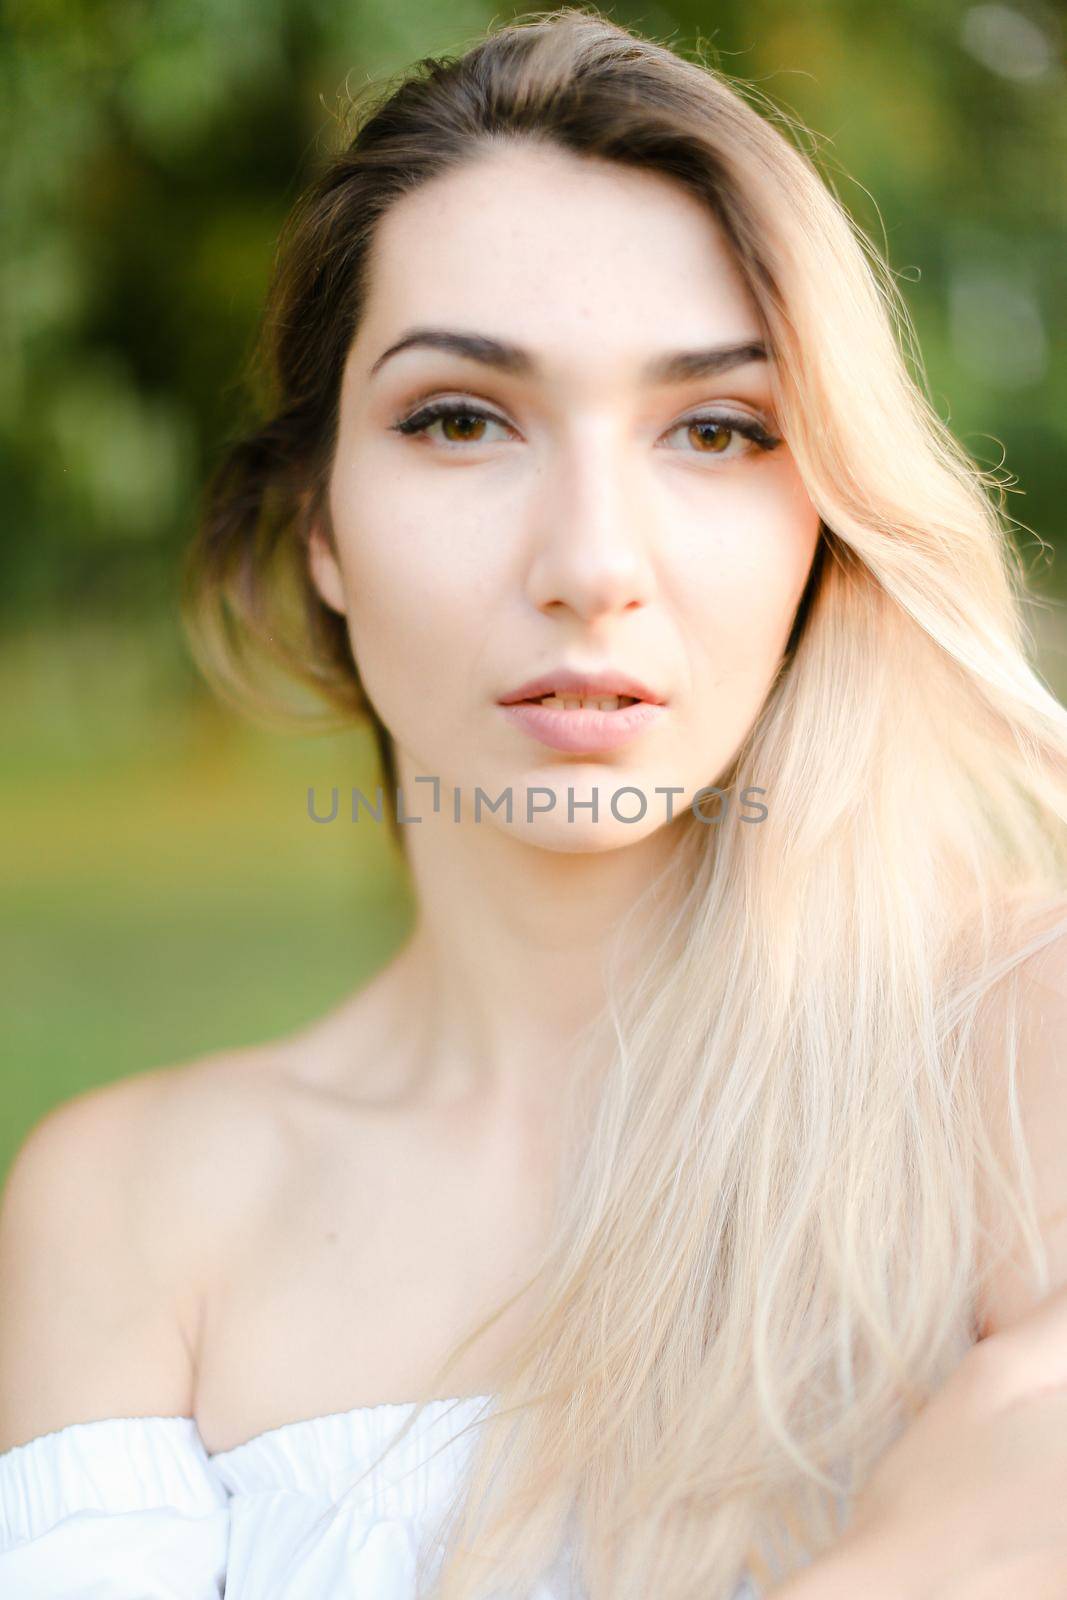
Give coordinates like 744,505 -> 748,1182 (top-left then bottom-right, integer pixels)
310,146 -> 819,851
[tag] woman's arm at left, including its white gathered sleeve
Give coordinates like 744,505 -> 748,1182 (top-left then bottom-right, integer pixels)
0,1074 -> 230,1600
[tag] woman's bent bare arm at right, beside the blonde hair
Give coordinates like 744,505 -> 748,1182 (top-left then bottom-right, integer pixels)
766,938 -> 1067,1600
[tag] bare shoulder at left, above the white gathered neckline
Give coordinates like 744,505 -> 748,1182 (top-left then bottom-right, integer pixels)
0,1046 -> 295,1451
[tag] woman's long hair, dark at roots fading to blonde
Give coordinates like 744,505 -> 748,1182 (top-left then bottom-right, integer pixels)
182,6 -> 1067,1600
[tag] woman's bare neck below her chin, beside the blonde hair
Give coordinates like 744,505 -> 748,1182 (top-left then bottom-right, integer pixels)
383,748 -> 684,1109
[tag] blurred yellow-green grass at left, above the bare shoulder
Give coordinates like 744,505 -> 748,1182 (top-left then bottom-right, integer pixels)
0,617 -> 413,1174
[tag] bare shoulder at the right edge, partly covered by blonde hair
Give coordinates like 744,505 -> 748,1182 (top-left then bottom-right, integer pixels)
979,906 -> 1067,1334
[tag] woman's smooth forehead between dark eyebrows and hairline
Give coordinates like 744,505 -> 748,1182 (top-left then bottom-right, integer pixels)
357,146 -> 761,390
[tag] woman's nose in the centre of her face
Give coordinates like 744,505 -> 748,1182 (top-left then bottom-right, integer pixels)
526,437 -> 654,621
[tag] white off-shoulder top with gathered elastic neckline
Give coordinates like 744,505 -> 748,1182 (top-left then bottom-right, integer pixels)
0,1395 -> 758,1600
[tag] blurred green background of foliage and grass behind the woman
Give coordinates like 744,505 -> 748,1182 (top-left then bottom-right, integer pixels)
0,0 -> 1067,1171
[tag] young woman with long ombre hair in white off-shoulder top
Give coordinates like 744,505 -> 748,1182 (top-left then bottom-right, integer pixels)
0,8 -> 1067,1600
